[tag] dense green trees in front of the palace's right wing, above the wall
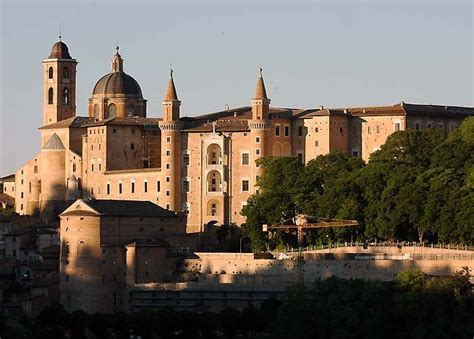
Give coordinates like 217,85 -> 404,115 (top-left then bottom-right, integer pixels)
242,117 -> 474,251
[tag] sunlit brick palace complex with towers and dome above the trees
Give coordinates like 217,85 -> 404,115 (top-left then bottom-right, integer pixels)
9,41 -> 474,233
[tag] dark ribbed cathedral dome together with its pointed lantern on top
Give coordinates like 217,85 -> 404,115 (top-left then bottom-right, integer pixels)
92,47 -> 143,99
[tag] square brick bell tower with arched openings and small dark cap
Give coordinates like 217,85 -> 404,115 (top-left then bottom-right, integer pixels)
43,37 -> 77,126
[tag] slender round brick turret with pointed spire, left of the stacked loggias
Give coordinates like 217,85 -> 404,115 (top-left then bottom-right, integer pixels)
159,70 -> 183,212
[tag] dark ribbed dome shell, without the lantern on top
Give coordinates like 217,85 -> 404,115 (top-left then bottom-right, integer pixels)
92,71 -> 143,99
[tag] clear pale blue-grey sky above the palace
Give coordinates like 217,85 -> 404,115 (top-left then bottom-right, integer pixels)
0,1 -> 474,176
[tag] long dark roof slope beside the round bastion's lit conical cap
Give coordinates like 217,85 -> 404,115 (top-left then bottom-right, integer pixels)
68,199 -> 176,217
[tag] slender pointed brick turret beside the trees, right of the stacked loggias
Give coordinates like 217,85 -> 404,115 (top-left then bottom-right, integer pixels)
249,68 -> 270,191
